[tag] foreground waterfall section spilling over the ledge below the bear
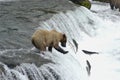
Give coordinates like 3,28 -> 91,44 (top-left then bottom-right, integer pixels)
0,51 -> 88,80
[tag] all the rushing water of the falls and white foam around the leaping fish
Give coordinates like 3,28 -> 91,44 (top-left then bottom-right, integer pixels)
0,1 -> 120,80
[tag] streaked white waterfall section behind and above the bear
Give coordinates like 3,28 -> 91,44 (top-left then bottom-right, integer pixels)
38,7 -> 101,41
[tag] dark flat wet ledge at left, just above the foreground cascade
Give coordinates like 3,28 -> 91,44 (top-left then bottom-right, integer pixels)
0,50 -> 51,68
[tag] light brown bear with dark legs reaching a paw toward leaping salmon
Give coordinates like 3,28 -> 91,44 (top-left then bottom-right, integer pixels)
32,29 -> 68,54
